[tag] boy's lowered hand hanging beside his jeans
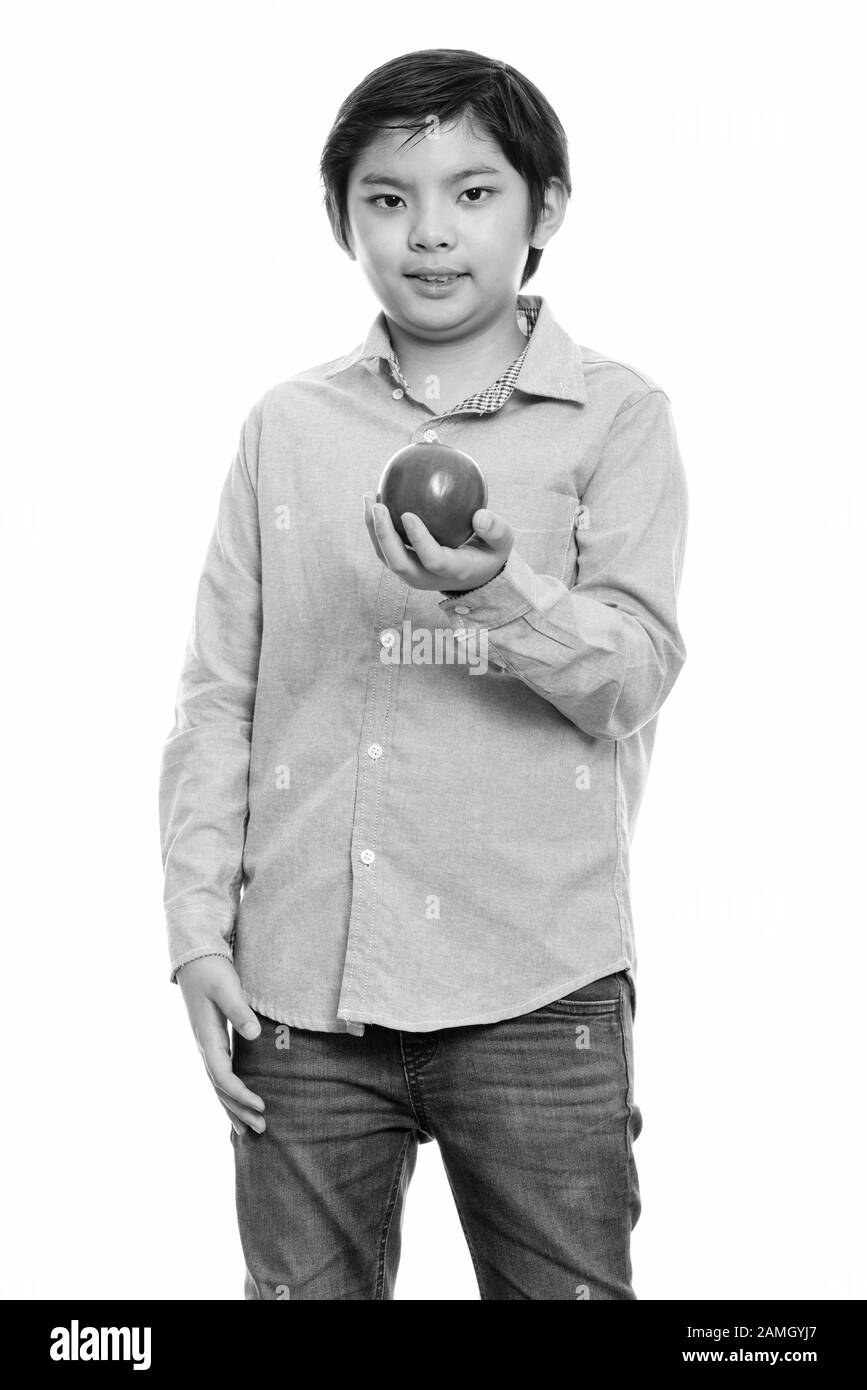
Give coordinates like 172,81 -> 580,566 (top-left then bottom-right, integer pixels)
178,955 -> 265,1134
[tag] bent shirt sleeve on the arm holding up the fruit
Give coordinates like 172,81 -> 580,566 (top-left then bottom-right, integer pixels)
440,386 -> 688,739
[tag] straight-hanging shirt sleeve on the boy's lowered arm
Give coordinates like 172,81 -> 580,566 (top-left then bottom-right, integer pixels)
160,411 -> 263,983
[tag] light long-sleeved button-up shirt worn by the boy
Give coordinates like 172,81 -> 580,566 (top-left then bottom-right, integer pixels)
160,295 -> 688,1034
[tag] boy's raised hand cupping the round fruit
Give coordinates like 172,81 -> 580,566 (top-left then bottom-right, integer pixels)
364,492 -> 514,591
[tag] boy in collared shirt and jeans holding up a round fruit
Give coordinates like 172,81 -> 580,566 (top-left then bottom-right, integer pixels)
160,49 -> 686,1300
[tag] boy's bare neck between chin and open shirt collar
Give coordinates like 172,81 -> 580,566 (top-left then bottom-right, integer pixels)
386,306 -> 527,410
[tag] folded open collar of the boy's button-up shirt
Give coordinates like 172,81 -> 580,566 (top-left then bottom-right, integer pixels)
325,295 -> 586,404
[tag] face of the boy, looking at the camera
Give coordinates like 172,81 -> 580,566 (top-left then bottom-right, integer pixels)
346,121 -> 547,341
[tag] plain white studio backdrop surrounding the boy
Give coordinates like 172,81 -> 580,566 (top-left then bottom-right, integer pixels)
0,0 -> 867,1300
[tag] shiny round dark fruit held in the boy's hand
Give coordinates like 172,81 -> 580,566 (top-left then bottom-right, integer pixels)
377,442 -> 488,549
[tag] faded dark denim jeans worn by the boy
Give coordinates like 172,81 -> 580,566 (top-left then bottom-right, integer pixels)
231,972 -> 642,1300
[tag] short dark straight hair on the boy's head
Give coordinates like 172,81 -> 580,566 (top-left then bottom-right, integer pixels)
320,49 -> 572,289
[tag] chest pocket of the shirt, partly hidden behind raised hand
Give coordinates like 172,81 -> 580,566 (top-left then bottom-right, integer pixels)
488,482 -> 581,588
